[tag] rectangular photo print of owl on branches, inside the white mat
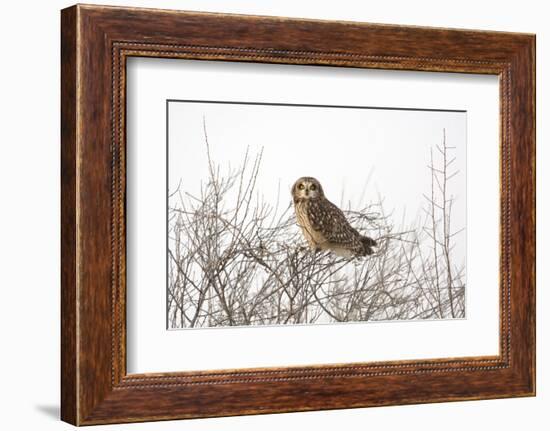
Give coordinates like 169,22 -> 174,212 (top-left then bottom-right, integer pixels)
166,100 -> 467,329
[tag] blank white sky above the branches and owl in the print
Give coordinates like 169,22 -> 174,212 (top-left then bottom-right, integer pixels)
168,101 -> 466,264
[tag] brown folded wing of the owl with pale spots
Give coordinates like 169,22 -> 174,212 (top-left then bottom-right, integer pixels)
308,199 -> 358,245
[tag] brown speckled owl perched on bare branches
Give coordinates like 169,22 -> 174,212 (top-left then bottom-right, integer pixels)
291,177 -> 376,258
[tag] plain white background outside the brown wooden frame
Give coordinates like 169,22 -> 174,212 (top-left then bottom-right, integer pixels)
0,0 -> 550,431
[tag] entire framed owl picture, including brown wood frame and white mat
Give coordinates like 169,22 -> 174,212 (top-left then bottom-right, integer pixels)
61,5 -> 535,425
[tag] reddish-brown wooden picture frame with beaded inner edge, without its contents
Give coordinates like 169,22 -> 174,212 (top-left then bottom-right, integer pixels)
61,5 -> 535,425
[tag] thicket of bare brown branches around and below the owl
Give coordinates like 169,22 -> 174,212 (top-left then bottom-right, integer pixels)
167,126 -> 465,328
